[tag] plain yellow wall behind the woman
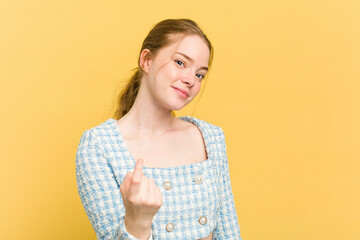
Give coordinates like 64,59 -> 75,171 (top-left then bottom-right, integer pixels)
0,0 -> 360,240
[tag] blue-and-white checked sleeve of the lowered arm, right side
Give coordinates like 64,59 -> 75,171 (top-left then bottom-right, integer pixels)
214,128 -> 241,240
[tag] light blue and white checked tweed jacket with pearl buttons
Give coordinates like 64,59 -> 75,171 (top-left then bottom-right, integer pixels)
76,116 -> 241,240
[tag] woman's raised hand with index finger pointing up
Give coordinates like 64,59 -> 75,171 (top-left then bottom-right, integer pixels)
120,158 -> 162,236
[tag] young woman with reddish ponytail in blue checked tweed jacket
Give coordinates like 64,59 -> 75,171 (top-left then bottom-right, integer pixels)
76,19 -> 241,240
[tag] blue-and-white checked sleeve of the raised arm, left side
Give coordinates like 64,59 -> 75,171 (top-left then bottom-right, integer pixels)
76,129 -> 151,240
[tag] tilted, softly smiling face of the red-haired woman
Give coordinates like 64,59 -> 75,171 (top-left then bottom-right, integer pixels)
143,35 -> 210,110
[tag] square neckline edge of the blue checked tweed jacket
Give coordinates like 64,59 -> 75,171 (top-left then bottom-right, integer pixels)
108,116 -> 212,171
